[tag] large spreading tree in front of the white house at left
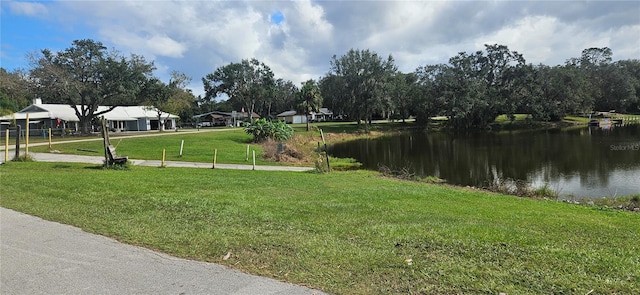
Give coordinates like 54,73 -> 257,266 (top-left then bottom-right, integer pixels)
29,39 -> 154,134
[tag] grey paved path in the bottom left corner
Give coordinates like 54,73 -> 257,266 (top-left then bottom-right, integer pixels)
0,207 -> 324,295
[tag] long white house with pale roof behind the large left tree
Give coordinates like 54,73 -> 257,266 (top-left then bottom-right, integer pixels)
0,99 -> 179,135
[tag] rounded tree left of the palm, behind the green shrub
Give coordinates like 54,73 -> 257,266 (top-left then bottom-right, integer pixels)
202,58 -> 275,121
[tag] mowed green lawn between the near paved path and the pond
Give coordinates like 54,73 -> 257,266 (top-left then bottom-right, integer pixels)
0,163 -> 640,294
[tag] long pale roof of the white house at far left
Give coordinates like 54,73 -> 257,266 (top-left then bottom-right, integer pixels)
0,104 -> 179,122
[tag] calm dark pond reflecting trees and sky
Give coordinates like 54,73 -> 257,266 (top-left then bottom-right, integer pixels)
329,124 -> 640,198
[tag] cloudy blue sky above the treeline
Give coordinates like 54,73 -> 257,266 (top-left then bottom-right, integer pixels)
0,0 -> 640,94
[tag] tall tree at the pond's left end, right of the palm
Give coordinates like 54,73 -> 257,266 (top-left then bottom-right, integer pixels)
329,49 -> 397,128
